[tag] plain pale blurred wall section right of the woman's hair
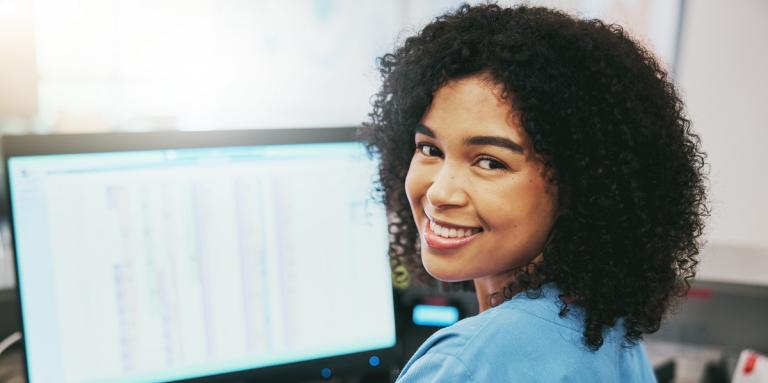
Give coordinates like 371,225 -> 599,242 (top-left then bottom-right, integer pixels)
677,0 -> 768,285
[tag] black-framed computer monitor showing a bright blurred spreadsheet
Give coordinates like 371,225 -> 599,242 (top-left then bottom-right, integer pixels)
3,128 -> 396,383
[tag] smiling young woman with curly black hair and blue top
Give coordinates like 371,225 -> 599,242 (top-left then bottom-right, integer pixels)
366,5 -> 708,382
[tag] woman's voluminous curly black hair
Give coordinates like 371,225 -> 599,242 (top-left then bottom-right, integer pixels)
363,4 -> 709,350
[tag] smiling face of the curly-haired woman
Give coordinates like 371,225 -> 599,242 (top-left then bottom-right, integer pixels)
405,76 -> 557,282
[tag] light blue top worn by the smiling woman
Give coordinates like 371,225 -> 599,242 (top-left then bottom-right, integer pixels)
397,283 -> 656,383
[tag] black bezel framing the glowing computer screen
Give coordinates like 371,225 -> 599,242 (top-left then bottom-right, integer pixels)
0,127 -> 402,383
